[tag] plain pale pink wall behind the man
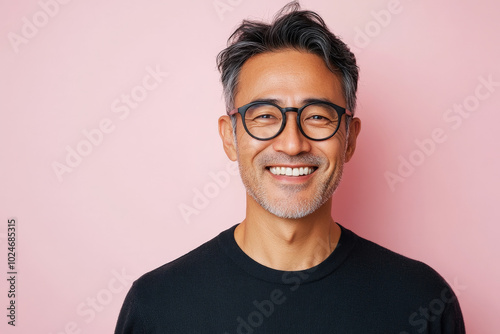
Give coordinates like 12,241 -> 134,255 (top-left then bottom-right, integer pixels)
0,0 -> 500,334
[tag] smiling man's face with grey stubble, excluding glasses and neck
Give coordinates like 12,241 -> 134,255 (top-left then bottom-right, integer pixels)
221,50 -> 357,218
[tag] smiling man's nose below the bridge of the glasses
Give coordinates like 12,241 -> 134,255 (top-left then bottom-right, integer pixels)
273,112 -> 311,156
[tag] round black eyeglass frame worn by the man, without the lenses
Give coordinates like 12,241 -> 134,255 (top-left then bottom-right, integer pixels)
228,100 -> 353,141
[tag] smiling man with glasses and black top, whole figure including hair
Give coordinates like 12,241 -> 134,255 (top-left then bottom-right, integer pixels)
115,3 -> 465,334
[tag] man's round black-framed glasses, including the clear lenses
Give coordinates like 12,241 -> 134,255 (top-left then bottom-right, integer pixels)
229,101 -> 352,141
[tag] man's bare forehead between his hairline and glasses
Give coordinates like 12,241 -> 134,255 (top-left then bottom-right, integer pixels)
235,49 -> 345,106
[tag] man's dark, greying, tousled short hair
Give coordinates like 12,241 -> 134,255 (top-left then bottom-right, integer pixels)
217,1 -> 358,113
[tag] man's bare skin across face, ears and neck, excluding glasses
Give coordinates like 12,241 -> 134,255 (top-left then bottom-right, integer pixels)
219,49 -> 361,271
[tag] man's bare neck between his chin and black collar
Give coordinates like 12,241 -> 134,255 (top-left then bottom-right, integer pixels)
234,194 -> 340,271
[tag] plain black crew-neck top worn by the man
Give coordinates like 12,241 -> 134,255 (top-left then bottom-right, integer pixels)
115,226 -> 465,334
